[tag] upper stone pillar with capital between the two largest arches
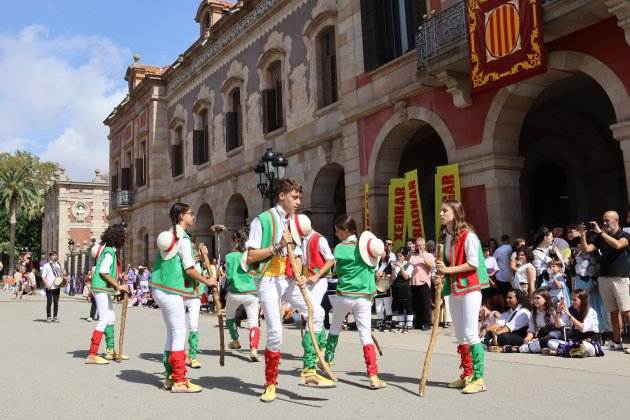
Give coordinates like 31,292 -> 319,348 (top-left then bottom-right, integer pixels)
460,155 -> 526,238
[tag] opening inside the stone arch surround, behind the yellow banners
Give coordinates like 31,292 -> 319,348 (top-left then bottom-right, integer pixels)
372,120 -> 448,238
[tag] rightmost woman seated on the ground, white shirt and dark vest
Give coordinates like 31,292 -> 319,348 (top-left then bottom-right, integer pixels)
548,289 -> 601,357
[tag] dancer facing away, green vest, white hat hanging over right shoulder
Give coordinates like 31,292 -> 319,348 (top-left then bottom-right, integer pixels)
325,215 -> 386,389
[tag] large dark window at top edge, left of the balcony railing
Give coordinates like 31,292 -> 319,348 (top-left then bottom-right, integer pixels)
361,0 -> 426,71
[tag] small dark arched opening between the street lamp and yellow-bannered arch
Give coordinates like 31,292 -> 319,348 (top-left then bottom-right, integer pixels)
310,163 -> 346,244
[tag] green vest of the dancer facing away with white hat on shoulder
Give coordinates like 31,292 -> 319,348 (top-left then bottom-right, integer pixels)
334,241 -> 376,299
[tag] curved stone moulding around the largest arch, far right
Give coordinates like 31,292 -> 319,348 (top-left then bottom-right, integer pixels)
481,51 -> 630,155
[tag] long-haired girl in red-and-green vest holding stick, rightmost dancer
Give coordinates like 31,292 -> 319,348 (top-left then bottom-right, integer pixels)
434,199 -> 488,394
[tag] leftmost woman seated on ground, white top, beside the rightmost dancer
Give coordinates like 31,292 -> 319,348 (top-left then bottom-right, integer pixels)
484,290 -> 531,351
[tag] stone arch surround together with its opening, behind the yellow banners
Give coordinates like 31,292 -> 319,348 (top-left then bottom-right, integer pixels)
368,106 -> 457,240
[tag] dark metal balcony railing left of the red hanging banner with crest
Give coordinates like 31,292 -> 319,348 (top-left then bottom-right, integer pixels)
416,1 -> 468,69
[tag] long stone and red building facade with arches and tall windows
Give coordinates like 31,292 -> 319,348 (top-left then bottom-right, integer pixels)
105,0 -> 630,264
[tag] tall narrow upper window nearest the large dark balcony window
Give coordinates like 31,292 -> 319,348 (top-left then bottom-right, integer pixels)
317,26 -> 338,107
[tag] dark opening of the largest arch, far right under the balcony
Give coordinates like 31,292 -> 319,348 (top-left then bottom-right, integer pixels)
519,72 -> 626,231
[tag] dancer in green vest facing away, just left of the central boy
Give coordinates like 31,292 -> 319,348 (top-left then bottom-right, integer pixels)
225,229 -> 260,362
